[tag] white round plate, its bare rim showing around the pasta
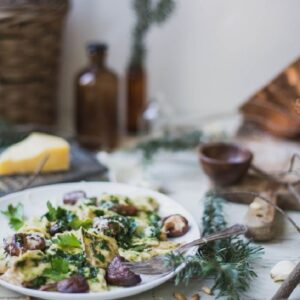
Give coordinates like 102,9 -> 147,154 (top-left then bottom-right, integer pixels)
0,182 -> 200,300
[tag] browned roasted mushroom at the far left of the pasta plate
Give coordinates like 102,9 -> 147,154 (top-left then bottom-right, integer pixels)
4,233 -> 46,256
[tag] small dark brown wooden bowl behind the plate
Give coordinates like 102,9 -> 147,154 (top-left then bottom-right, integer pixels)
199,143 -> 253,186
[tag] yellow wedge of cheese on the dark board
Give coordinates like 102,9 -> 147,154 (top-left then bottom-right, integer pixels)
0,133 -> 70,175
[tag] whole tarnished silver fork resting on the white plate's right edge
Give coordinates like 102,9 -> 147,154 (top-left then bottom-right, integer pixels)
123,224 -> 247,275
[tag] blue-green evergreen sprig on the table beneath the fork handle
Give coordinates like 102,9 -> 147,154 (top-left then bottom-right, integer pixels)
166,195 -> 262,300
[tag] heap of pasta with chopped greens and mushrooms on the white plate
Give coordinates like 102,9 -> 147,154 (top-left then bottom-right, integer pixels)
0,191 -> 183,293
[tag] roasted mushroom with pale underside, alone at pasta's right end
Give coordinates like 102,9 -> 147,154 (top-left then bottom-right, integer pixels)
162,214 -> 189,237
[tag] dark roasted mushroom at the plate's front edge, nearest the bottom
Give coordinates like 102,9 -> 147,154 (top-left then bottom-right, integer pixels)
56,275 -> 89,294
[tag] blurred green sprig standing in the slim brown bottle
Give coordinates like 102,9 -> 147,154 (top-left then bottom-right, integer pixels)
129,0 -> 175,67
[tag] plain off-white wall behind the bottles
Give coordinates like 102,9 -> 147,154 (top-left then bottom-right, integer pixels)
59,0 -> 300,132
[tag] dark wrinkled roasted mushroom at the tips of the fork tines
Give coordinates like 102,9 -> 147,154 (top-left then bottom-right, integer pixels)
106,256 -> 142,286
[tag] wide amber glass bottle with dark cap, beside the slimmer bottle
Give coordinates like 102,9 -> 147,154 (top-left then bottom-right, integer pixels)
76,44 -> 118,150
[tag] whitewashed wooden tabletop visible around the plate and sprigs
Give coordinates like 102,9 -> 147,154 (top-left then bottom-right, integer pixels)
0,129 -> 300,300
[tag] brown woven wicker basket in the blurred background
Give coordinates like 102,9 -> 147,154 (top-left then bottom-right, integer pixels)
0,0 -> 69,127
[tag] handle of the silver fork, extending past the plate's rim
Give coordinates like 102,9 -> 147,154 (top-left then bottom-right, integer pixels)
176,224 -> 247,253
